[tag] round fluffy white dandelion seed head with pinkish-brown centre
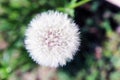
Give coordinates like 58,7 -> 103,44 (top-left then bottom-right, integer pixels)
25,11 -> 80,67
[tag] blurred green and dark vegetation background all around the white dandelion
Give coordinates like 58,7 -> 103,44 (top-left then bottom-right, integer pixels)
0,0 -> 120,80
